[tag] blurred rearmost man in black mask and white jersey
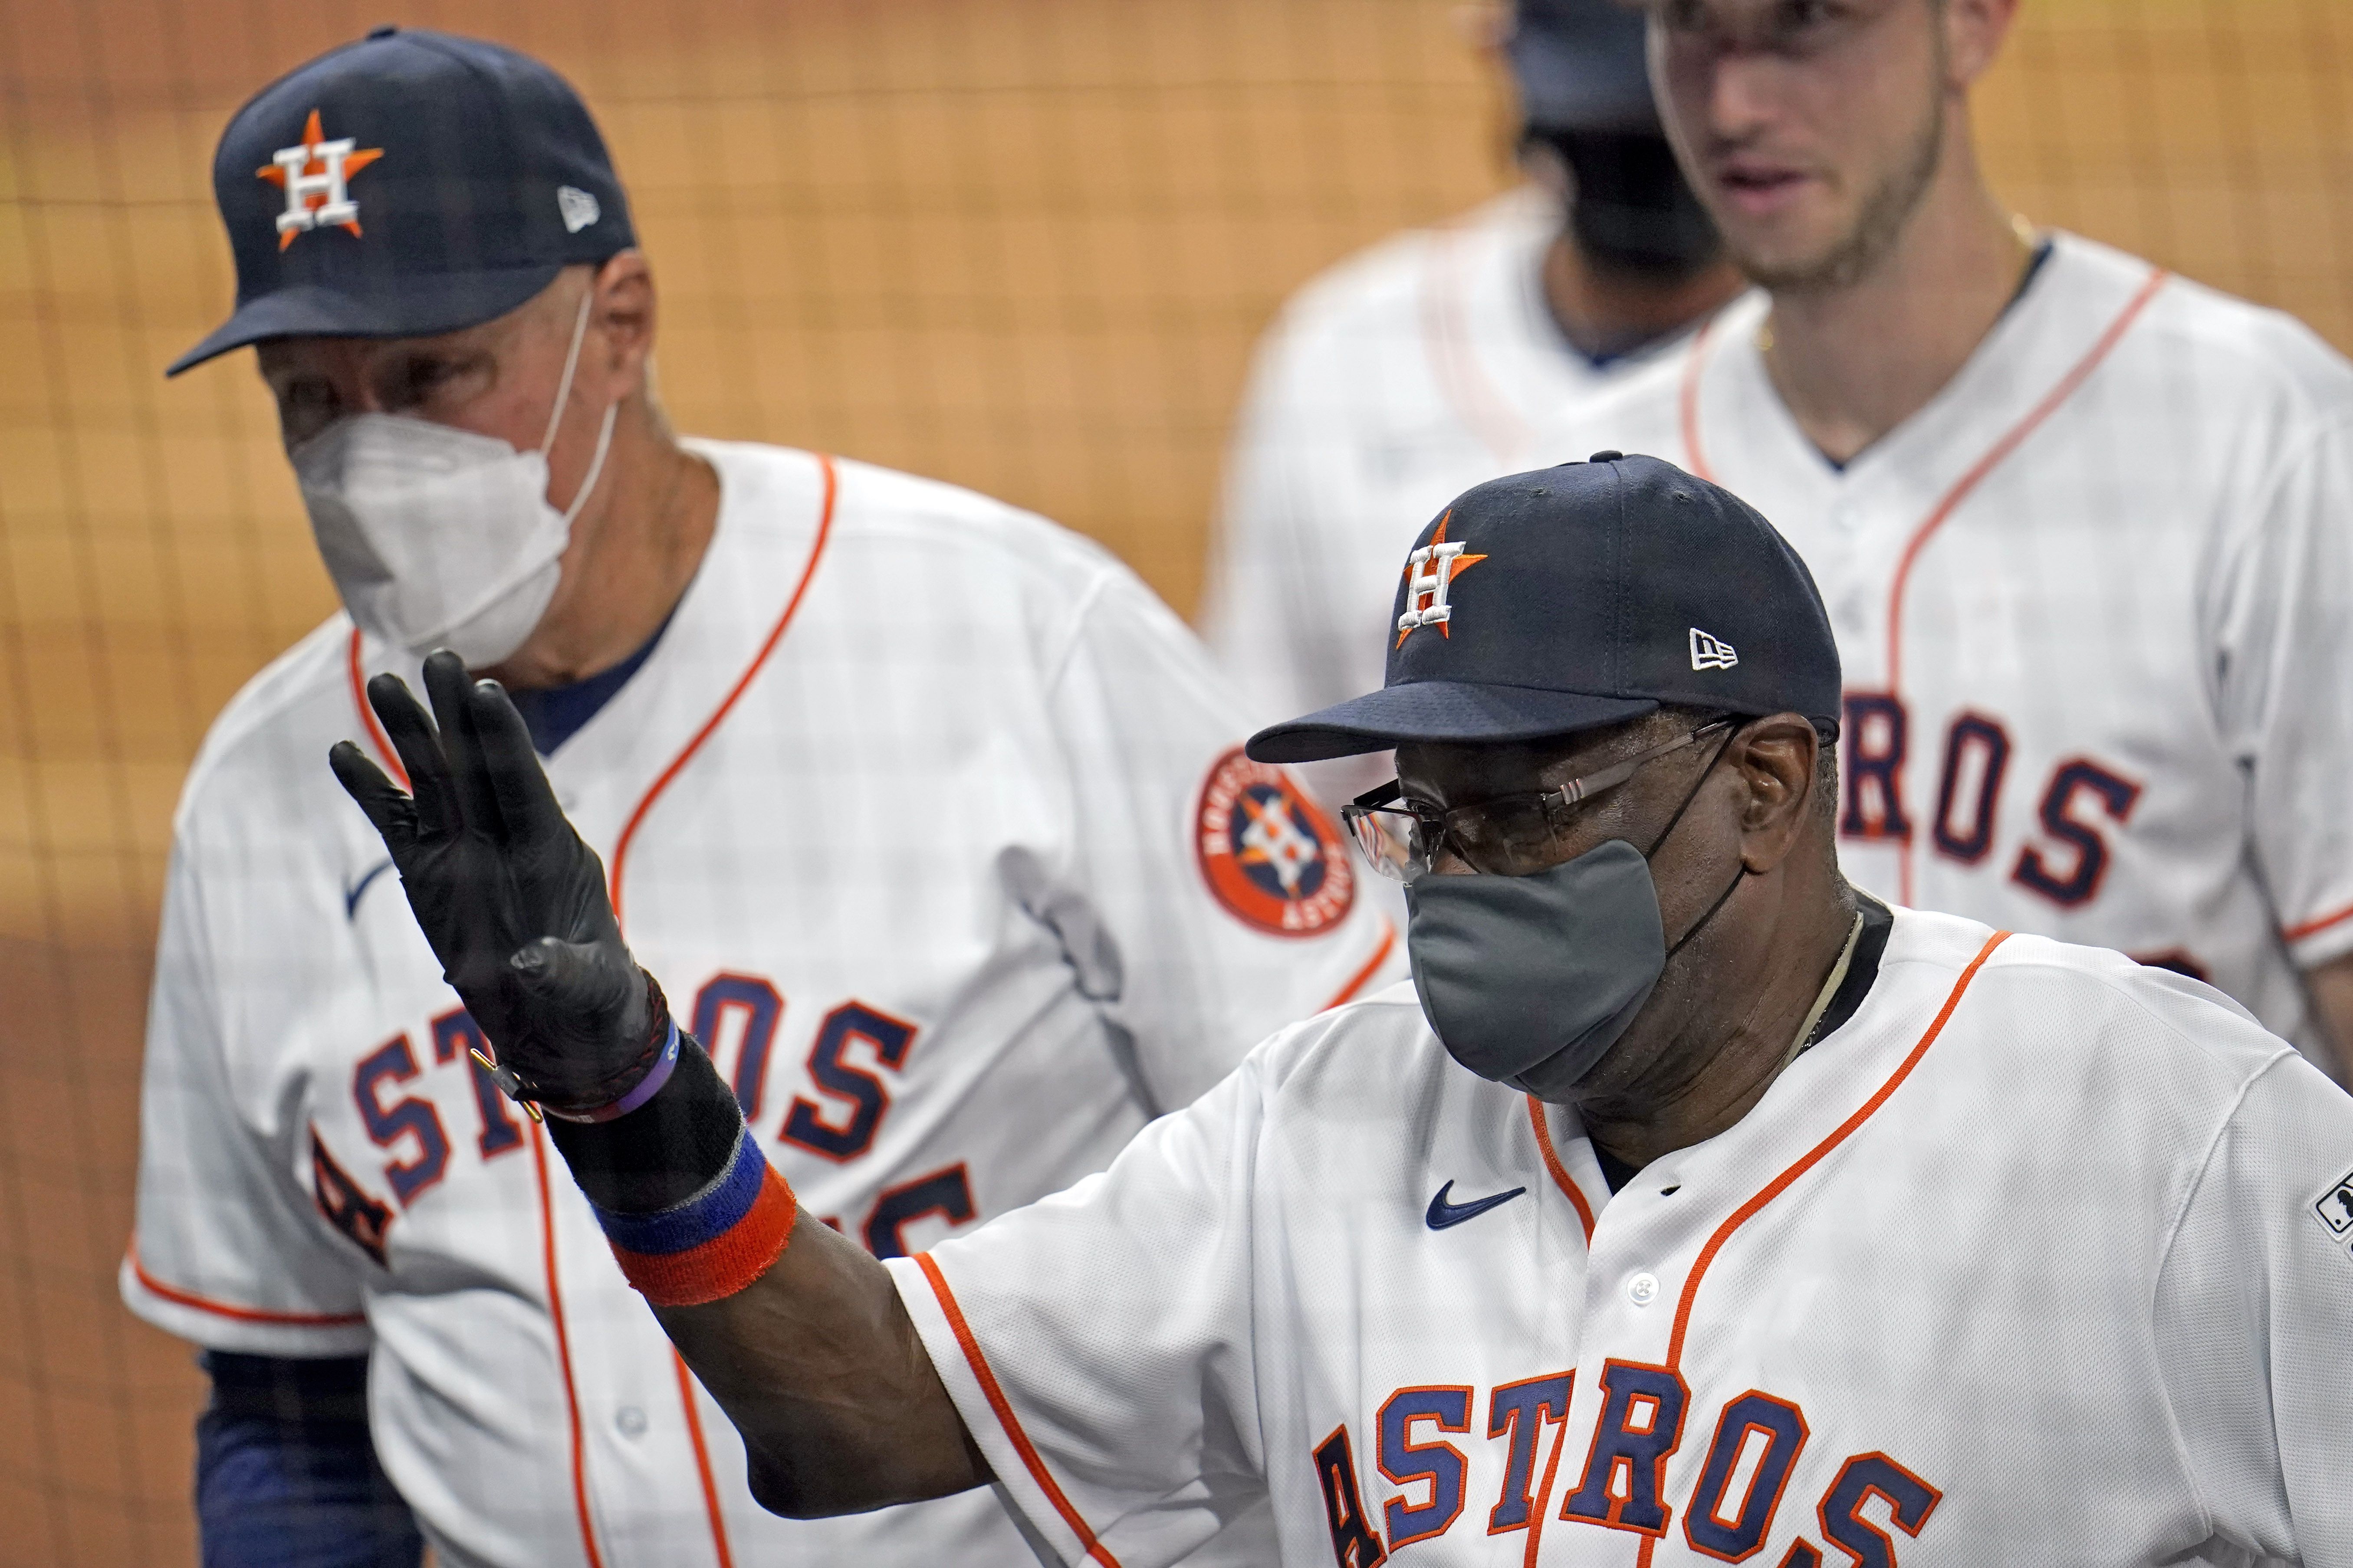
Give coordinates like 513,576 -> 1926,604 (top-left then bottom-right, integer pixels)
1203,0 -> 1741,802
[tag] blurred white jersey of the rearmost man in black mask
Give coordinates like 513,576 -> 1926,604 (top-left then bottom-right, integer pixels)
1203,186 -> 1694,797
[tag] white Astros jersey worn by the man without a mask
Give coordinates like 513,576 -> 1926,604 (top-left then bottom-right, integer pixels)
1555,235 -> 2353,1044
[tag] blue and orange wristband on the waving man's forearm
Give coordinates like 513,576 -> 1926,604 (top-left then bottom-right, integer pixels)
591,1126 -> 800,1307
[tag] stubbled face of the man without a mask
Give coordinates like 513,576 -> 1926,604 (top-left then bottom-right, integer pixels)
1650,0 -> 1953,289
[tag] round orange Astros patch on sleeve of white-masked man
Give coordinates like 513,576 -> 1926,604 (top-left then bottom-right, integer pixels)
1193,748 -> 1355,935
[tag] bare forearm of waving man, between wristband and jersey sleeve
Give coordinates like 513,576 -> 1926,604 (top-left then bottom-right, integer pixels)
654,1215 -> 988,1519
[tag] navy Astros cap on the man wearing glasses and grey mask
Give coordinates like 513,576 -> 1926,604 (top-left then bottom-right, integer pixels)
1249,451 -> 1840,762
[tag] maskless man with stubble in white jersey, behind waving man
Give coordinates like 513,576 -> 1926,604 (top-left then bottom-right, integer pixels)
1562,0 -> 2353,1077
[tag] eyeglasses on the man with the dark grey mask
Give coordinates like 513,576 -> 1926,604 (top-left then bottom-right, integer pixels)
1339,717 -> 1734,882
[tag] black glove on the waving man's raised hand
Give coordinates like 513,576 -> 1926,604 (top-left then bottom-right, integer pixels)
327,649 -> 668,1114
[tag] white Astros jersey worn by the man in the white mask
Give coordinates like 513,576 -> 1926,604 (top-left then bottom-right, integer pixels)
122,442 -> 1395,1568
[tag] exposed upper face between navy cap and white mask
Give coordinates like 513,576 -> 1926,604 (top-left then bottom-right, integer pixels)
254,268 -> 588,451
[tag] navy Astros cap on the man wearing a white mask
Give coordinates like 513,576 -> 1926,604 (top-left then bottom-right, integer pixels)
165,28 -> 638,376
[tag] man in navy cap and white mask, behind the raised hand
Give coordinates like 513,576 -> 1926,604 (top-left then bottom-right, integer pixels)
122,28 -> 1393,1568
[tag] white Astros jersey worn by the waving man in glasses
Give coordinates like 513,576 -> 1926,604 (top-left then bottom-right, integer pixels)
890,910 -> 2353,1568
